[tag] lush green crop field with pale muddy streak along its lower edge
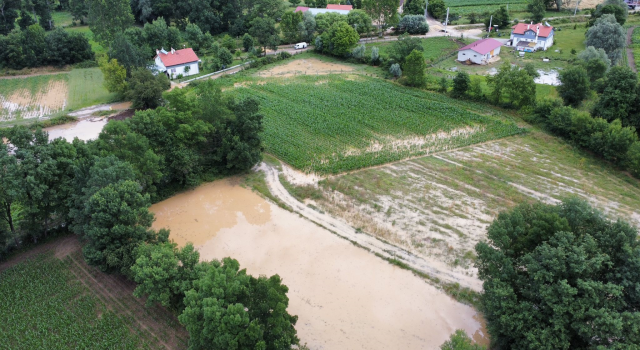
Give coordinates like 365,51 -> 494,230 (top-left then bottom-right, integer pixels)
231,75 -> 523,174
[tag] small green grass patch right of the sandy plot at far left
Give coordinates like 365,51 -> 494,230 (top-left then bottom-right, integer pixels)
67,68 -> 116,110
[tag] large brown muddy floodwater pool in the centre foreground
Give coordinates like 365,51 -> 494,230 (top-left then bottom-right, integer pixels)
151,179 -> 487,350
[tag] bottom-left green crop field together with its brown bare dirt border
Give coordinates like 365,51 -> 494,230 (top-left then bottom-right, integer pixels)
0,240 -> 188,350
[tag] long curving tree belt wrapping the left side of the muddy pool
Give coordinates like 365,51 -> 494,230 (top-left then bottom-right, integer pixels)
0,81 -> 298,349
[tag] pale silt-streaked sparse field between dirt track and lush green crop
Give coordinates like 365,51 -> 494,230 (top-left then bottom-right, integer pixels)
308,131 -> 640,276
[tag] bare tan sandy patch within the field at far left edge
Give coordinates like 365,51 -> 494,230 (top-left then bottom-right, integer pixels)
0,80 -> 69,120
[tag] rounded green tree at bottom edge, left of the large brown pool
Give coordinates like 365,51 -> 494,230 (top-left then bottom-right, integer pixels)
178,258 -> 299,350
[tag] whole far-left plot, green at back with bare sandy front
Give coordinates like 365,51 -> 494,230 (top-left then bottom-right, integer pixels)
0,74 -> 68,121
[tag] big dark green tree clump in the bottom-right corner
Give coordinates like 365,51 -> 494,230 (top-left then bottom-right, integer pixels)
475,199 -> 640,350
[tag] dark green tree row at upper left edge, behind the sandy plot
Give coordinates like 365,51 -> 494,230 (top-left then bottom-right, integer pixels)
0,23 -> 94,69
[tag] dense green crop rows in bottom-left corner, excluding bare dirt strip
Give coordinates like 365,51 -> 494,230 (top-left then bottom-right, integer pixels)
0,255 -> 149,350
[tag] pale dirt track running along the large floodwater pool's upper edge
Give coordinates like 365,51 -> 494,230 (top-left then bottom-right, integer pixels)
259,163 -> 482,291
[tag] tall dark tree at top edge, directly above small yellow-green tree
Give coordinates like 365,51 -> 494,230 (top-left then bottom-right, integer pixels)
87,0 -> 133,45
